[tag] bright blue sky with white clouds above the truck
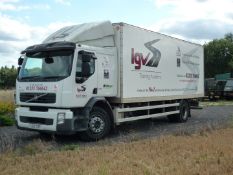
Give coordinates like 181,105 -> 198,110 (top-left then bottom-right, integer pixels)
0,0 -> 233,67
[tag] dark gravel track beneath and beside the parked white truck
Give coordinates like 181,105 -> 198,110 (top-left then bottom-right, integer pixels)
0,106 -> 233,152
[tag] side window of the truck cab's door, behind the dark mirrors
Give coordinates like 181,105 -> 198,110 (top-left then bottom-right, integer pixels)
76,51 -> 96,83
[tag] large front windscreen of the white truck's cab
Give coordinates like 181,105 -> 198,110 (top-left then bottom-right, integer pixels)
18,50 -> 73,81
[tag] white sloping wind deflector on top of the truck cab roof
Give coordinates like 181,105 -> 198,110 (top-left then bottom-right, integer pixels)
43,21 -> 114,47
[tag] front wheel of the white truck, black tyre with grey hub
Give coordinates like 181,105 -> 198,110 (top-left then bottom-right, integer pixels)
80,107 -> 111,141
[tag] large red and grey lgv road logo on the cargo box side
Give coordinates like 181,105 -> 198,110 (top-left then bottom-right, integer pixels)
131,39 -> 161,69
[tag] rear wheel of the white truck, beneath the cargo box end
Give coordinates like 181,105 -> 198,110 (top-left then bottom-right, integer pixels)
167,100 -> 190,123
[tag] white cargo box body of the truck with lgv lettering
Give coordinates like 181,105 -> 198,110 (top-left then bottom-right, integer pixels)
113,23 -> 204,103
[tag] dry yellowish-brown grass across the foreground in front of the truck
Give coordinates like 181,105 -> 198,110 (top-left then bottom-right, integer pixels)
0,128 -> 233,175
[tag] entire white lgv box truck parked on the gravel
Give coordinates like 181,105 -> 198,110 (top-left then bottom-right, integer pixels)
15,21 -> 204,140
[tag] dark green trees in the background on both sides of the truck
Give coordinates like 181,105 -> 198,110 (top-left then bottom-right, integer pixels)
0,33 -> 233,89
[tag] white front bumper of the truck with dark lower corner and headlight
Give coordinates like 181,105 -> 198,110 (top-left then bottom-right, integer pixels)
15,107 -> 86,134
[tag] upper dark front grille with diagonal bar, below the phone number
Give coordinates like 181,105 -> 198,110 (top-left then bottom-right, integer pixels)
20,93 -> 56,103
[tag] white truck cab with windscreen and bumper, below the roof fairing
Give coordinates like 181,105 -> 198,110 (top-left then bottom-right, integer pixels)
16,42 -> 117,140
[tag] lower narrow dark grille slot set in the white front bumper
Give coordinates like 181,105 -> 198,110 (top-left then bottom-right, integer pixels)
20,116 -> 53,125
